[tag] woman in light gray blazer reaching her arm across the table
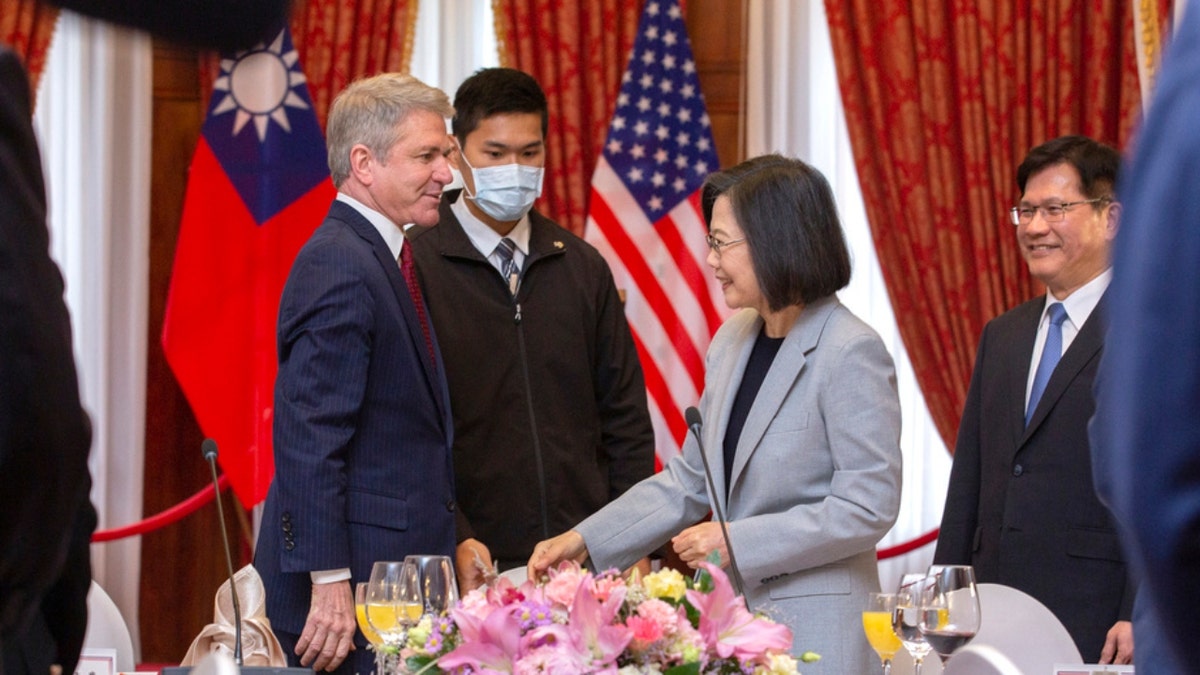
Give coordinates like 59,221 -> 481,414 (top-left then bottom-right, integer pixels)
529,155 -> 900,675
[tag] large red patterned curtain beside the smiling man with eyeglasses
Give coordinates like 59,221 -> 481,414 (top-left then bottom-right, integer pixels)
826,0 -> 1140,448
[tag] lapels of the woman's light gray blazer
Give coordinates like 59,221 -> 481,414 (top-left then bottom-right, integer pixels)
730,297 -> 839,491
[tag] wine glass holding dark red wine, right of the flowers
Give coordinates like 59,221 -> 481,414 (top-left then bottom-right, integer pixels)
920,565 -> 980,663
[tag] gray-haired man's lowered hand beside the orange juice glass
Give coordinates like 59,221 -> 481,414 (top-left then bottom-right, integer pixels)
296,580 -> 358,670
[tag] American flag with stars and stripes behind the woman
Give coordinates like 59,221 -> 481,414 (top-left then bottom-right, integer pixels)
586,0 -> 727,462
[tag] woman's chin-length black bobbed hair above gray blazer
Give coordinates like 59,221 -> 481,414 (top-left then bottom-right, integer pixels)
701,155 -> 850,311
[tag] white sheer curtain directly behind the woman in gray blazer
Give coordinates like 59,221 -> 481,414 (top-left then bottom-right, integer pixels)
745,0 -> 950,589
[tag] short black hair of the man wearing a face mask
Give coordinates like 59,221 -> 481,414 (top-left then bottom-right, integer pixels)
450,68 -> 550,143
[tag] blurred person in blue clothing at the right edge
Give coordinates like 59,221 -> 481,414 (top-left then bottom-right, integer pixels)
1090,4 -> 1200,674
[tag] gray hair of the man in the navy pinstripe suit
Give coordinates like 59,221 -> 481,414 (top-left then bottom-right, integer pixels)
325,73 -> 454,187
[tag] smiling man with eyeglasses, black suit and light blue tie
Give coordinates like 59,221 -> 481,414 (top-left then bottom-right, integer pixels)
934,136 -> 1136,664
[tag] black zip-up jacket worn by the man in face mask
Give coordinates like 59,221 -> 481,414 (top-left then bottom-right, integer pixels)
409,191 -> 654,567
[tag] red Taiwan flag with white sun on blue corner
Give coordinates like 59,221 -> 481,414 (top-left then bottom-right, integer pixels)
162,29 -> 335,508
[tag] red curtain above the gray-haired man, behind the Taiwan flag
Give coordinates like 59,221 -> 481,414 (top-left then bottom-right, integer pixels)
200,0 -> 419,129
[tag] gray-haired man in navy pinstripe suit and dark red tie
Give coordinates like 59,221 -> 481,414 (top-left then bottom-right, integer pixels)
254,73 -> 455,675
